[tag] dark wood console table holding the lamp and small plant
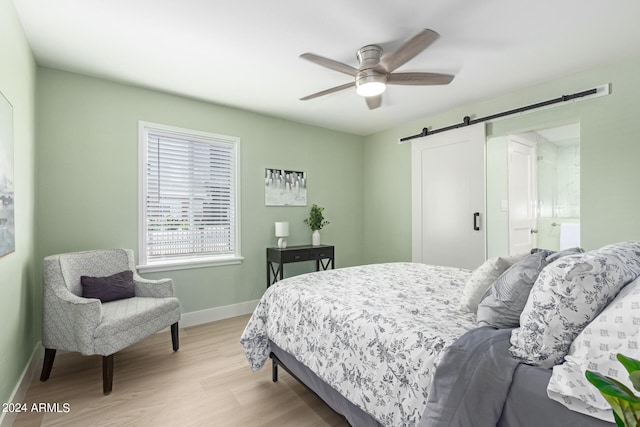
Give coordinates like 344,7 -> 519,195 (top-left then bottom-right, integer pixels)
267,245 -> 335,287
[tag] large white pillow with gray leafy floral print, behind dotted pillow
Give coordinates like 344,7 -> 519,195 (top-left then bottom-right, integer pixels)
509,242 -> 640,368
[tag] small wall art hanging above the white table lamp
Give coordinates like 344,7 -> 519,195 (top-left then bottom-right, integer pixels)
264,168 -> 307,206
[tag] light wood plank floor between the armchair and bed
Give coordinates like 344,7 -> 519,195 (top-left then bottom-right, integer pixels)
14,316 -> 348,427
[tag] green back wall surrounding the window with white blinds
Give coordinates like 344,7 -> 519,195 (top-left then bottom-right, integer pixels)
37,68 -> 364,313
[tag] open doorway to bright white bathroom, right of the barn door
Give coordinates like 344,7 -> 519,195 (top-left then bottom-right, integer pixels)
508,123 -> 580,254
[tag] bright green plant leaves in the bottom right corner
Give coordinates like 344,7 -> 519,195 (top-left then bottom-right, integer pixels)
585,354 -> 640,427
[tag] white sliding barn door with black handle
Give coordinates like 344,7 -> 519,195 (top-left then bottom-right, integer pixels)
411,123 -> 486,269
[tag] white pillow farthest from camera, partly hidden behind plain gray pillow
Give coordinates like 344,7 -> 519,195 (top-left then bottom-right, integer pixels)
460,254 -> 527,313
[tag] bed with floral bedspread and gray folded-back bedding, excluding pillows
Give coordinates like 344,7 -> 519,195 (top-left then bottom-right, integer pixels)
241,242 -> 640,427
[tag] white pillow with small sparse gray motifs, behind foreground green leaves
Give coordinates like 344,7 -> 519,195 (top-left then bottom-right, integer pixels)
547,279 -> 640,422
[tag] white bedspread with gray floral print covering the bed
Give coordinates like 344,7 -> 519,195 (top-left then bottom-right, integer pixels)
240,263 -> 476,426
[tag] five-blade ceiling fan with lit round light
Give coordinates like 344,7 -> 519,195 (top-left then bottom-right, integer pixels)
300,29 -> 454,110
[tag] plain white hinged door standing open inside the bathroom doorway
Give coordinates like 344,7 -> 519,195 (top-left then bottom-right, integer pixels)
508,135 -> 538,255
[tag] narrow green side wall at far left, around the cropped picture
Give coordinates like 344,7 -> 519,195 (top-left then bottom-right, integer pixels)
0,0 -> 41,414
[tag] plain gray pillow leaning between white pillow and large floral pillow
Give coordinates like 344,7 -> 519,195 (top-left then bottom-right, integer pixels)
478,250 -> 553,328
